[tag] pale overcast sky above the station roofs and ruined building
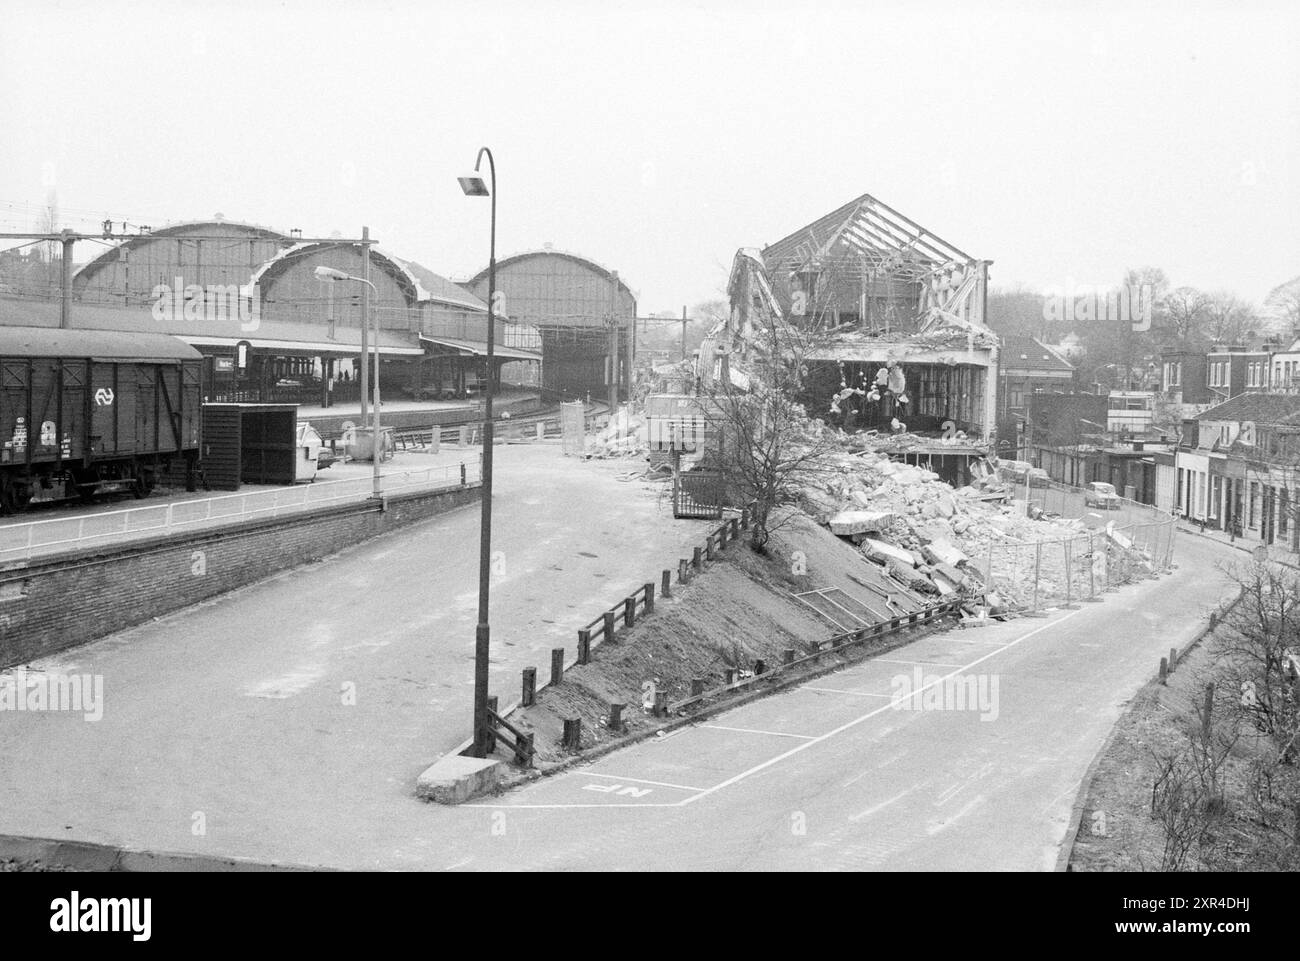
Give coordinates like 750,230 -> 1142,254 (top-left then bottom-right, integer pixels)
0,0 -> 1300,315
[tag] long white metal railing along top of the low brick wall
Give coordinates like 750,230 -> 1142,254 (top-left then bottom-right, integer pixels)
0,459 -> 481,563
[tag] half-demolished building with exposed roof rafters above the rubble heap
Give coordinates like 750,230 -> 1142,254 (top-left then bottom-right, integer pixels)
719,194 -> 997,446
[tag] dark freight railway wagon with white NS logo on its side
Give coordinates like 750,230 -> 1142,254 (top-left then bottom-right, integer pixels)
0,325 -> 203,514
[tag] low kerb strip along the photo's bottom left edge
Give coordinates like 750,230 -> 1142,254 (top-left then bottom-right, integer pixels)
0,835 -> 323,873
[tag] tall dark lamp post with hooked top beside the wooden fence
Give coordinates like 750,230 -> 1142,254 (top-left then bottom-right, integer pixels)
458,147 -> 497,757
